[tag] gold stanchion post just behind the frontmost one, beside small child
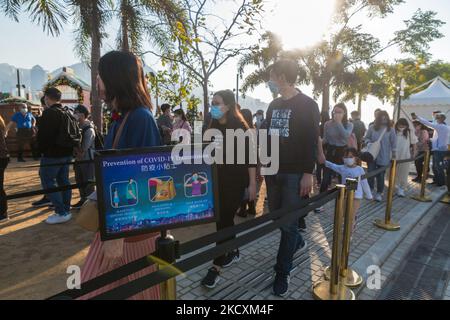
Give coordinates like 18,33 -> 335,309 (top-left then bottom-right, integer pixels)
325,179 -> 363,288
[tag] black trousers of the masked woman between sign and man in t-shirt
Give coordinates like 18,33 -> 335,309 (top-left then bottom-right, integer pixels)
213,182 -> 246,266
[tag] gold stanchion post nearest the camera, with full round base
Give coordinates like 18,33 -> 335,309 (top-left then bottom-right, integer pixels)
313,185 -> 355,300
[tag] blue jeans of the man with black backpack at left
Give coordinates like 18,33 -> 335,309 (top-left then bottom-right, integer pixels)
39,157 -> 72,215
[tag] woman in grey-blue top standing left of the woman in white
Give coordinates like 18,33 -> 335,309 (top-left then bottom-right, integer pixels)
364,111 -> 397,202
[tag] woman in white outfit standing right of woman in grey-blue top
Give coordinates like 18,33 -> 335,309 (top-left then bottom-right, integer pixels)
395,118 -> 417,197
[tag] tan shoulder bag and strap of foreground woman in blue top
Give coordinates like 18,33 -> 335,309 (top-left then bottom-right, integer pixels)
76,112 -> 130,232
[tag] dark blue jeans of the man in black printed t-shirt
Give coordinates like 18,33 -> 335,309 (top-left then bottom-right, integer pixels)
265,174 -> 304,275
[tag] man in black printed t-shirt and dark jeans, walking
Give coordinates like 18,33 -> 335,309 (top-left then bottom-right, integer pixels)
265,60 -> 320,296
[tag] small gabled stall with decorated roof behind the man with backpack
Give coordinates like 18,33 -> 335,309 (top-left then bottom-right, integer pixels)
43,67 -> 91,108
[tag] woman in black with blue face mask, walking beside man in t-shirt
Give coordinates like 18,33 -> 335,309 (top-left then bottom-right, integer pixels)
202,90 -> 256,288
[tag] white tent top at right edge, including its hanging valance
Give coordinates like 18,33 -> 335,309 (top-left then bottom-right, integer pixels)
401,77 -> 450,119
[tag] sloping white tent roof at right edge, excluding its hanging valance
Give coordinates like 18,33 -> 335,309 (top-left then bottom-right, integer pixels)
402,77 -> 450,108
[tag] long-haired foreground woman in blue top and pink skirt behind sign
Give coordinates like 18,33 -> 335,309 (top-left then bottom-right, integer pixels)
81,51 -> 161,300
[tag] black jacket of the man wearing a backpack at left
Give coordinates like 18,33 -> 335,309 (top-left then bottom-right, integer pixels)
37,104 -> 73,158
